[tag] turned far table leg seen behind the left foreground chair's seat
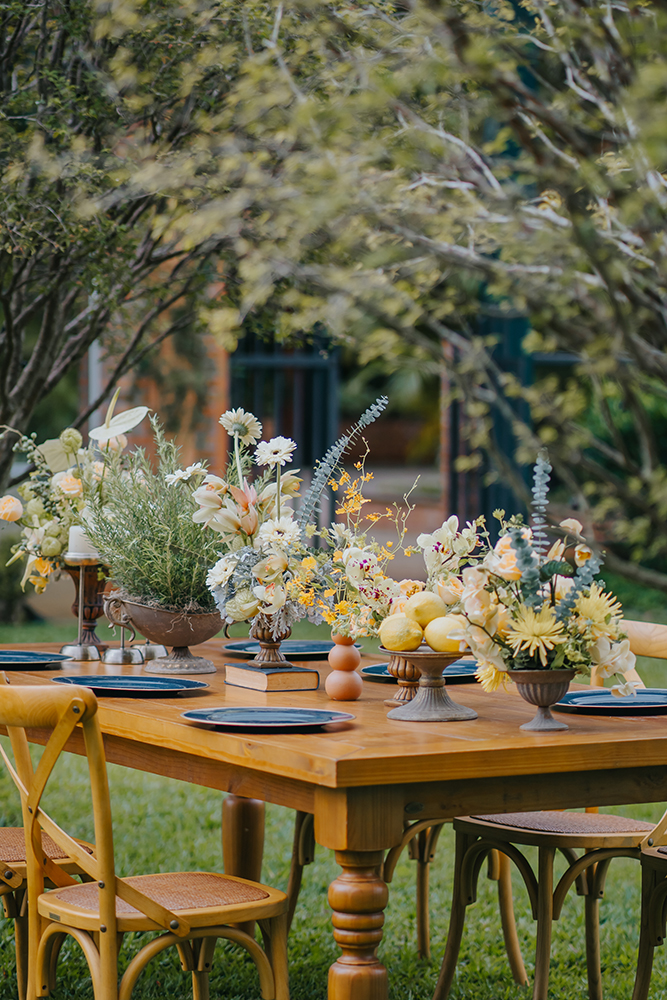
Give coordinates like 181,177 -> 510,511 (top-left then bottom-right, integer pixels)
222,795 -> 265,935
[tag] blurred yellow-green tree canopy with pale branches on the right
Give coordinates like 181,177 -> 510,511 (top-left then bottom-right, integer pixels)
99,0 -> 667,586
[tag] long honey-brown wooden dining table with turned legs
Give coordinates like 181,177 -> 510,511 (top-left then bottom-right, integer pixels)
5,640 -> 667,1000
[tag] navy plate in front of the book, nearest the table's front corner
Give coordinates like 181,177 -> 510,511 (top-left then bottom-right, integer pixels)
181,706 -> 354,733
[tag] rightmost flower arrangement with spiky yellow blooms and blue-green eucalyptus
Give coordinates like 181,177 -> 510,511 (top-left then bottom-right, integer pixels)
455,455 -> 636,696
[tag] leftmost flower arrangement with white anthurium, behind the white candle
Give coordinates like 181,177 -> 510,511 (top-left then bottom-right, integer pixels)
0,392 -> 148,594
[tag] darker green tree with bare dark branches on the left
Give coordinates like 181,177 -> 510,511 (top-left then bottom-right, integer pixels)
0,0 -> 284,482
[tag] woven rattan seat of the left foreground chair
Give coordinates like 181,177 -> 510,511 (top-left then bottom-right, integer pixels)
43,872 -> 269,916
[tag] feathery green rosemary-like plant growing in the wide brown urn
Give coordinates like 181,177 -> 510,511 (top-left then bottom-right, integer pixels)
87,418 -> 220,613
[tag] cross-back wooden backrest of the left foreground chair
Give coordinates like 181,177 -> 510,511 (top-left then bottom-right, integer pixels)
0,673 -> 190,937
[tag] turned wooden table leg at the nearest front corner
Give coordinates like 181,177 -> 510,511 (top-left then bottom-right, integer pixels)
329,851 -> 389,1000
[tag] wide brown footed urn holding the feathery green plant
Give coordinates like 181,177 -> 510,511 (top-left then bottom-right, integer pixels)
110,598 -> 222,674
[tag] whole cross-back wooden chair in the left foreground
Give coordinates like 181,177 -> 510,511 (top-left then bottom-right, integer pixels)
0,676 -> 289,1000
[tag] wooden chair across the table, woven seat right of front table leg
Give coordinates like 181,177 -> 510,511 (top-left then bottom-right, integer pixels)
433,621 -> 667,1000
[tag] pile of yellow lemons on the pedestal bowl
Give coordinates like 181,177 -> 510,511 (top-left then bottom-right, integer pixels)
379,590 -> 466,653
